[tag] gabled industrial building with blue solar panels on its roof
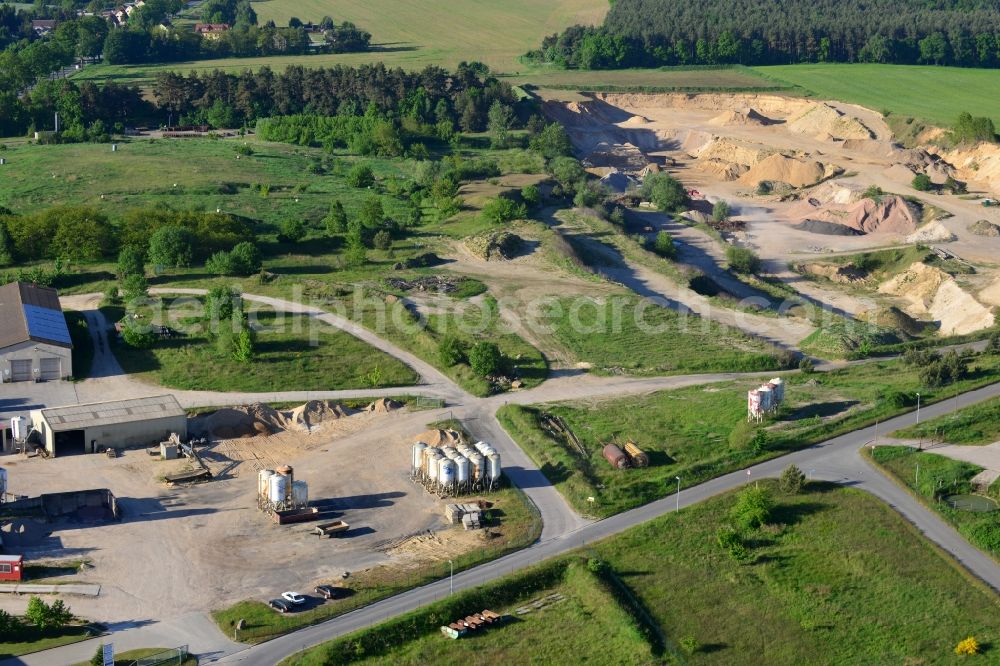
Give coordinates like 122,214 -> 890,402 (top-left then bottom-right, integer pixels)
0,282 -> 73,382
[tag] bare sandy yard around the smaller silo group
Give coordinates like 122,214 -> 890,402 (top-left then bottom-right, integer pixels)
0,410 -> 488,622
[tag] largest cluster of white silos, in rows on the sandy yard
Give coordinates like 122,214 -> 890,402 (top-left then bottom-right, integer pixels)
410,442 -> 502,495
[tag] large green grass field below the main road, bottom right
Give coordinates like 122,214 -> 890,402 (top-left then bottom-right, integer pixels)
286,482 -> 1000,666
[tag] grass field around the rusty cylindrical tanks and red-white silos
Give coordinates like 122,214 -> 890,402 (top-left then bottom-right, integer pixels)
498,356 -> 1000,517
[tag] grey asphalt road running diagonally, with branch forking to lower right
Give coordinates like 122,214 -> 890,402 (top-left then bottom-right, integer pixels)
218,383 -> 1000,665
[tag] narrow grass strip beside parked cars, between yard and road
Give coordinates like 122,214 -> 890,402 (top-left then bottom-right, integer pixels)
212,488 -> 542,643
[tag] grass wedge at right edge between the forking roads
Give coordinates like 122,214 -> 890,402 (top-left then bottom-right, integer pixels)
866,446 -> 1000,559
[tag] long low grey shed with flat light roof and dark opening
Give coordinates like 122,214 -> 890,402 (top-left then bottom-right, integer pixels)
31,395 -> 187,456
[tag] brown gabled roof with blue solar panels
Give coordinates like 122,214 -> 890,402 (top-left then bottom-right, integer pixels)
0,282 -> 73,348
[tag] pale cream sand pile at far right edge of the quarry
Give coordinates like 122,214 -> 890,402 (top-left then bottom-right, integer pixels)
879,261 -> 994,335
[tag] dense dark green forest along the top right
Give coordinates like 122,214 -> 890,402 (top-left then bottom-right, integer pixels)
526,0 -> 1000,69
